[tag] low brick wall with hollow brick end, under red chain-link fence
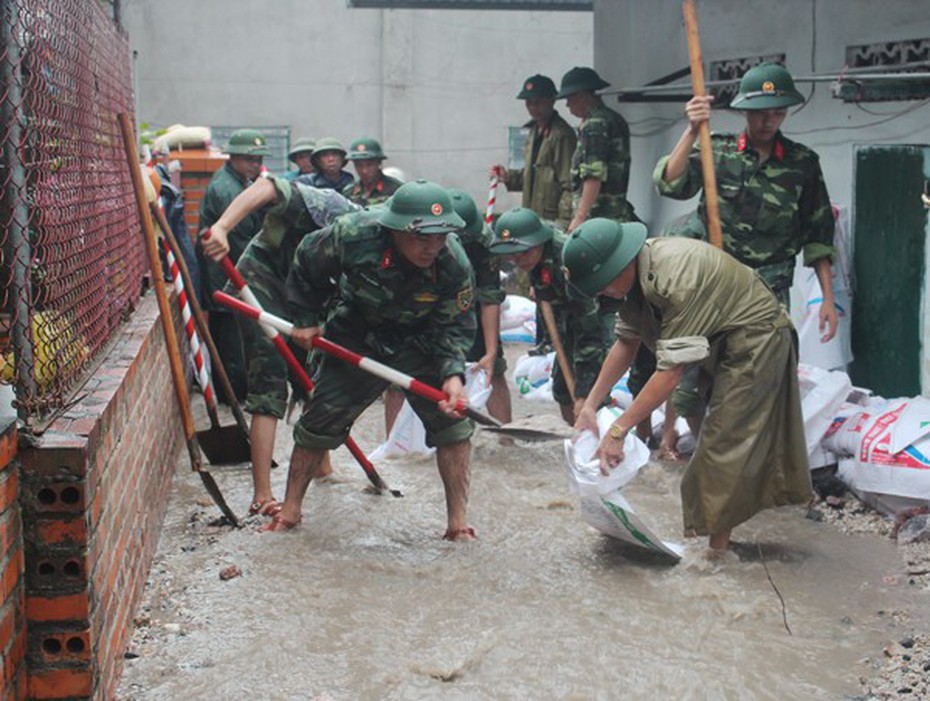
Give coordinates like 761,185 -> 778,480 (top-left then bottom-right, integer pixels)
21,294 -> 183,699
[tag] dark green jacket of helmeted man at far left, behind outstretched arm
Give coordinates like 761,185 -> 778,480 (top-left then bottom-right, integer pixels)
198,163 -> 263,300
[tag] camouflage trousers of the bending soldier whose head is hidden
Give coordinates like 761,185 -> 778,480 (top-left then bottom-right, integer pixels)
234,241 -> 307,419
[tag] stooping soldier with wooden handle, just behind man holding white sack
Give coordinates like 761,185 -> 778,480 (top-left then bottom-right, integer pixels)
491,207 -> 610,424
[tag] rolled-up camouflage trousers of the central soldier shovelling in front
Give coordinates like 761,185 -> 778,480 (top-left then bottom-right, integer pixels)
294,320 -> 474,450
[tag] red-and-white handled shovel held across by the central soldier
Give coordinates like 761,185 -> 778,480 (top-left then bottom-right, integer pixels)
213,291 -> 564,441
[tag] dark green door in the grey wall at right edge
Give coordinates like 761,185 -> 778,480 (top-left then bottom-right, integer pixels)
850,146 -> 930,398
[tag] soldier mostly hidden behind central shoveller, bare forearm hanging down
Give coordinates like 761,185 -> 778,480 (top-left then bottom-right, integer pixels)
449,188 -> 513,424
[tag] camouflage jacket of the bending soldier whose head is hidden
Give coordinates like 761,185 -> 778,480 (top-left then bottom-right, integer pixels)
250,177 -> 359,280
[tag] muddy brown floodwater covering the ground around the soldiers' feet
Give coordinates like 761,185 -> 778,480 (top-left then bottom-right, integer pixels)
120,356 -> 926,701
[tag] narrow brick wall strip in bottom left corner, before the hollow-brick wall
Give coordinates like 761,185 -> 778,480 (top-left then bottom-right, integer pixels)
0,419 -> 26,701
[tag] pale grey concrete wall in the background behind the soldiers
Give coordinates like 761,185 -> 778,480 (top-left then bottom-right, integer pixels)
122,0 -> 593,208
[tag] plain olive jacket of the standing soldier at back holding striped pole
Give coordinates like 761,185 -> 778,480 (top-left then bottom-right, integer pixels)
507,112 -> 578,229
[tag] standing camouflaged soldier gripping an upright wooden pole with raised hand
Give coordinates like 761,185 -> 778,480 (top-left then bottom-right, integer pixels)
653,63 -> 837,430
